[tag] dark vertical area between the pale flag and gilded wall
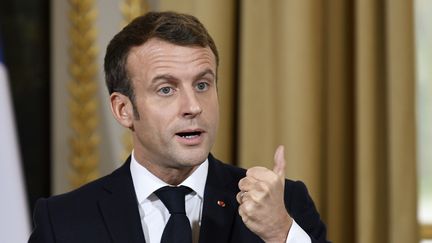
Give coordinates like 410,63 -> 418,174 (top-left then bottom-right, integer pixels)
0,0 -> 50,213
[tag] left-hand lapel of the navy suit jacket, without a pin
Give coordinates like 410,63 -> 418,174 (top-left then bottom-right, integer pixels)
99,158 -> 145,243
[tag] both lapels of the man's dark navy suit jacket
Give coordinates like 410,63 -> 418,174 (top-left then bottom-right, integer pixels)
95,155 -> 243,243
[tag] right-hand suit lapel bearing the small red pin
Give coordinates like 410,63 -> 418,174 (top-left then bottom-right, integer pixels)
199,155 -> 238,243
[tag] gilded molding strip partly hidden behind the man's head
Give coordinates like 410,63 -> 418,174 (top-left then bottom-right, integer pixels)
120,0 -> 149,160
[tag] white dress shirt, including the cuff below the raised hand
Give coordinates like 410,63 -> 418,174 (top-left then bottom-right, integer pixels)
130,152 -> 311,243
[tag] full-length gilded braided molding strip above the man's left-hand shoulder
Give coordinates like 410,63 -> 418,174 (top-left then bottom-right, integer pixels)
68,0 -> 100,188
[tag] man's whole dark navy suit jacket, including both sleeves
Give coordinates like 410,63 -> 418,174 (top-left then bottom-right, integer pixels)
29,155 -> 326,243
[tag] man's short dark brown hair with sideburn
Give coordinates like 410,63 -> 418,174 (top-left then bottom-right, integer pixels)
104,12 -> 219,115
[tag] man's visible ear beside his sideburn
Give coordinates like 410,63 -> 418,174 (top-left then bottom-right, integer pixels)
110,92 -> 133,128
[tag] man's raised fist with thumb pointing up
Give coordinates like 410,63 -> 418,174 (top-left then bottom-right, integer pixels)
237,146 -> 293,243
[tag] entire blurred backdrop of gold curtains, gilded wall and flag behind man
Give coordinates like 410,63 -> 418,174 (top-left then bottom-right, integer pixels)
0,0 -> 432,243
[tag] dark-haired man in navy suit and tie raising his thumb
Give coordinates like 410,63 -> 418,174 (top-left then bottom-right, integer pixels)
29,12 -> 326,243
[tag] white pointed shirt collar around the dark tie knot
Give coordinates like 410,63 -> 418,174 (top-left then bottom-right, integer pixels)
130,151 -> 208,203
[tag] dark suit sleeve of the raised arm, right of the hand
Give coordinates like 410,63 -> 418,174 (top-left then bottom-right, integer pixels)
285,181 -> 328,243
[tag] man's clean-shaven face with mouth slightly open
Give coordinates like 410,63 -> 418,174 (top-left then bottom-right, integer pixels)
127,39 -> 219,175
